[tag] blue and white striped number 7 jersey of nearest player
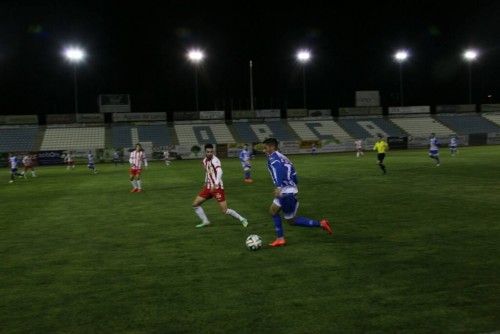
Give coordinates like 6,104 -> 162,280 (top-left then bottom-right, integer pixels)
267,152 -> 299,194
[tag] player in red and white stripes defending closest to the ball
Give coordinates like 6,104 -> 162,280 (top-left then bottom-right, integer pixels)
193,144 -> 248,227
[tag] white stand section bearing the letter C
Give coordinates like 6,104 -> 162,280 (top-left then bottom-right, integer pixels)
288,120 -> 353,142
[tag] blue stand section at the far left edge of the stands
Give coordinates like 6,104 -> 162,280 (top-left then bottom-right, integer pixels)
0,127 -> 39,152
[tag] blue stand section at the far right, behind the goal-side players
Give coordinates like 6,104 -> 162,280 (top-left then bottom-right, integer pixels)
436,115 -> 500,135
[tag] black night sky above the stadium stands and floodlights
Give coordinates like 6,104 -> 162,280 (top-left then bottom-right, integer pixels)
0,1 -> 500,114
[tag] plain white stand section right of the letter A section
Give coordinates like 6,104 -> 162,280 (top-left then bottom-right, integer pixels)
390,116 -> 454,137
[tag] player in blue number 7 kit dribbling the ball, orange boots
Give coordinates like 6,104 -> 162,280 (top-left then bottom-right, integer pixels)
263,138 -> 332,247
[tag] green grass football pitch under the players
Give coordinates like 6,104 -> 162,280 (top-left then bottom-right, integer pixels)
0,146 -> 500,333
